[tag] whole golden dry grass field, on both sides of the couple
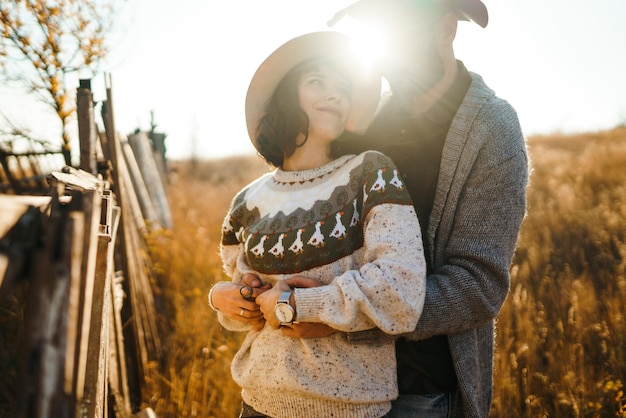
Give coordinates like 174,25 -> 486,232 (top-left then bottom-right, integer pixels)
144,127 -> 626,418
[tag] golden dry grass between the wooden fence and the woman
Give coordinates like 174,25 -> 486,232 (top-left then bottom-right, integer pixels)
145,157 -> 268,418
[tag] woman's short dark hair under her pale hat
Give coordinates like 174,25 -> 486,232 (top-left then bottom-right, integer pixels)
256,58 -> 352,167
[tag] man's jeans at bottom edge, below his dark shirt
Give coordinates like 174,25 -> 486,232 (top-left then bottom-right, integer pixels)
387,393 -> 453,418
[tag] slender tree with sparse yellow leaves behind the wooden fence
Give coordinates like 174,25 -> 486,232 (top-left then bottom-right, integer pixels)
0,0 -> 122,164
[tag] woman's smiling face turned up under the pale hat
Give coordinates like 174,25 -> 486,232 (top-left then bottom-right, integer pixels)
298,63 -> 351,142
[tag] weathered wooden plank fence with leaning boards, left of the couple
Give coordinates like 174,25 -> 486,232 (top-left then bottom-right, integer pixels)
0,78 -> 172,418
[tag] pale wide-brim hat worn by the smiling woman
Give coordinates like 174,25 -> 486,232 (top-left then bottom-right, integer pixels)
246,31 -> 381,147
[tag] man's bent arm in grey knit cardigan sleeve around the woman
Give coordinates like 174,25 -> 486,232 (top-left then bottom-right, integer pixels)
407,137 -> 528,340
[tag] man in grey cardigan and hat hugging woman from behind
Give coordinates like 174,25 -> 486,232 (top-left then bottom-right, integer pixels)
322,0 -> 528,417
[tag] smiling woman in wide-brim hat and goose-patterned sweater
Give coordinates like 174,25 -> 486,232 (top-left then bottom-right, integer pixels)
209,32 -> 426,418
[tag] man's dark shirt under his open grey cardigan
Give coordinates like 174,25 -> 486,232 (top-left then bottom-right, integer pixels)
333,61 -> 471,394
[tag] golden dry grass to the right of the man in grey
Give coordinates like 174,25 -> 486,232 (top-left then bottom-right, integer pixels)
493,128 -> 626,417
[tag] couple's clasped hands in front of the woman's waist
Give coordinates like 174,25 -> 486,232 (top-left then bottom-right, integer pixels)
211,273 -> 336,338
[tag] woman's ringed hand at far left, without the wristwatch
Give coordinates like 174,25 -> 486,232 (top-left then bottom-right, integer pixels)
211,274 -> 270,331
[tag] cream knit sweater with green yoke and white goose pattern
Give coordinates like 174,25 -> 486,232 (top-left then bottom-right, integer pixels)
219,151 -> 426,418
